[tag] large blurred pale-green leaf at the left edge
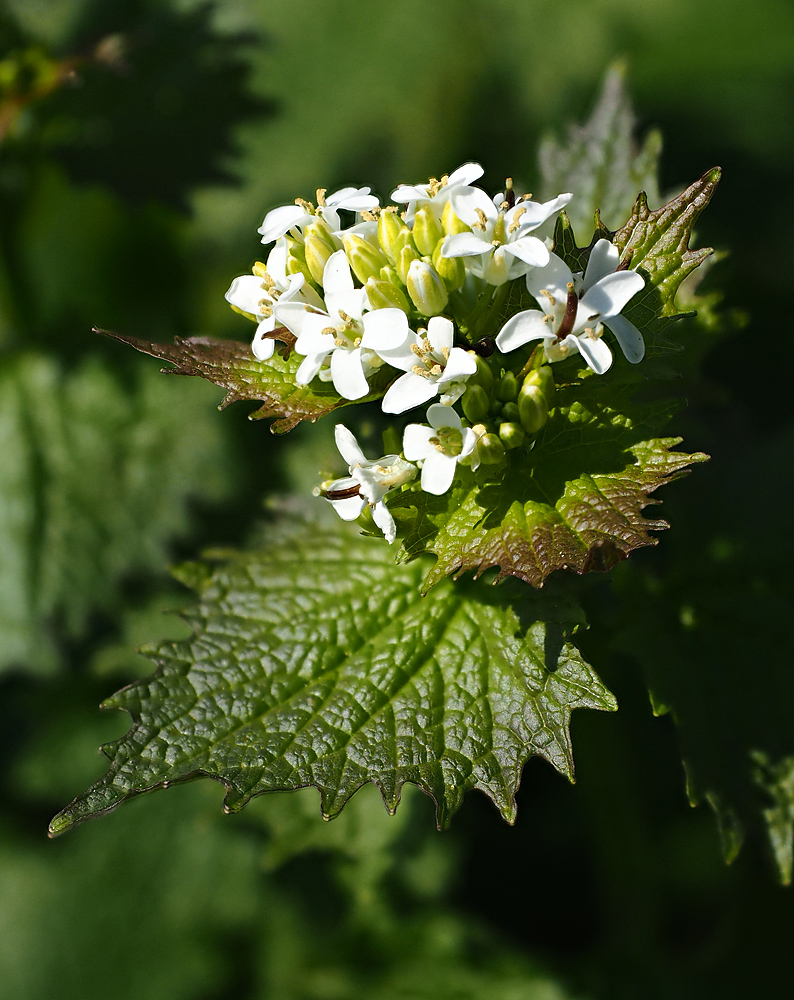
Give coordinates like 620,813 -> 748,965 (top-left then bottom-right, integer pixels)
0,355 -> 229,671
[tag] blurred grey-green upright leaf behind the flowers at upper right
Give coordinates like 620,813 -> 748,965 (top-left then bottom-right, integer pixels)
539,65 -> 662,240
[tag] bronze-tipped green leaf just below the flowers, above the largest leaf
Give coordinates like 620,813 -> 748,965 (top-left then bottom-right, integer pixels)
389,438 -> 706,590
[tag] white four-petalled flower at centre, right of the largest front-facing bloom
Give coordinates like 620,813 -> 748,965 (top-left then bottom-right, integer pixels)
377,318 -> 477,413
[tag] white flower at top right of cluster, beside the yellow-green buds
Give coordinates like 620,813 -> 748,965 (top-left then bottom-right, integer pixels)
441,187 -> 573,285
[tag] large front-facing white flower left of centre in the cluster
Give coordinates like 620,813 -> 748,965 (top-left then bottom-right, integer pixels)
275,250 -> 409,399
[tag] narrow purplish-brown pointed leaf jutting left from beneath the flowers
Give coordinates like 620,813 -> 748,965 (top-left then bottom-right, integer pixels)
95,329 -> 390,434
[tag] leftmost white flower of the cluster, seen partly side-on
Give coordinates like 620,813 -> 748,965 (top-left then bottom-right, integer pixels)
225,239 -> 322,361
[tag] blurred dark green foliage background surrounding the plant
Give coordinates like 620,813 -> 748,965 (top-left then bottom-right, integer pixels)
0,0 -> 794,1000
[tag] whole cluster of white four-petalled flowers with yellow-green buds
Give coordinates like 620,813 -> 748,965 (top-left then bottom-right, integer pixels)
226,163 -> 645,541
